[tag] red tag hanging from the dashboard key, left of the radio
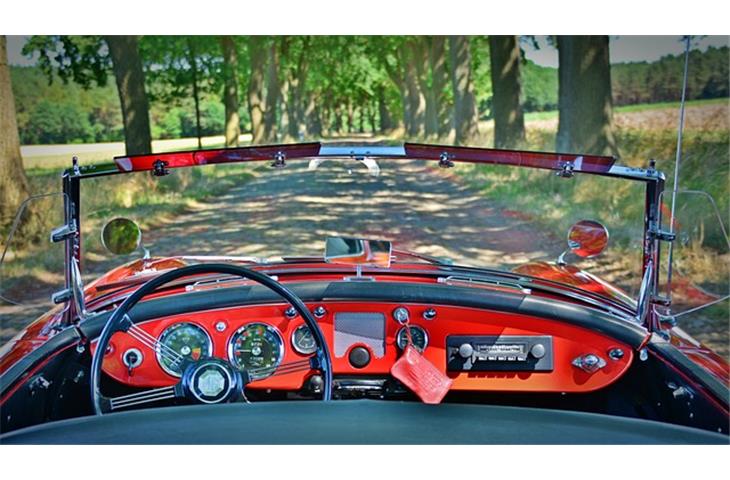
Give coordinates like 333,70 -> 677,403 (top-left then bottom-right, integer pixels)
390,342 -> 452,404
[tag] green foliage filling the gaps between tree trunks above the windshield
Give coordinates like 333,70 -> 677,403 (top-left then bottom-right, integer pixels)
11,35 -> 730,144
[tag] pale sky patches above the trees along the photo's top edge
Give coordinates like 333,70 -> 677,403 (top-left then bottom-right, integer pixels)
8,35 -> 730,67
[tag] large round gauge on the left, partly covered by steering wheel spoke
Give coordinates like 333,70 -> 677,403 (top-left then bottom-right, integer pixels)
156,322 -> 213,377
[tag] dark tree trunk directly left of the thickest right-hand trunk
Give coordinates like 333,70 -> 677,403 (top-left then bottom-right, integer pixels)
489,35 -> 525,148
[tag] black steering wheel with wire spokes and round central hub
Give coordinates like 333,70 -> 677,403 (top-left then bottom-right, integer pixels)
91,263 -> 332,415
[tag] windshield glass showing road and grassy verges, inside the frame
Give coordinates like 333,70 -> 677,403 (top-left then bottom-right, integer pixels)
81,159 -> 644,298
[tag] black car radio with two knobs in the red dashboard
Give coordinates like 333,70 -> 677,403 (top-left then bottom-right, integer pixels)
446,335 -> 553,372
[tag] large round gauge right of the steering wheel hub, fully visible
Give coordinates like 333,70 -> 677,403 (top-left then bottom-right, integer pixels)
228,323 -> 284,379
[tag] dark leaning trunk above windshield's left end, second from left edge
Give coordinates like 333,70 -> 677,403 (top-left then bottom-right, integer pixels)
104,35 -> 152,155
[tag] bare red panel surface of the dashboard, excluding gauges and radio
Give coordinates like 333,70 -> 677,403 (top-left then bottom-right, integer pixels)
96,302 -> 633,392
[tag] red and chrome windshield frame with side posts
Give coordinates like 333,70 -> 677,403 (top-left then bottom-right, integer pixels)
52,142 -> 665,330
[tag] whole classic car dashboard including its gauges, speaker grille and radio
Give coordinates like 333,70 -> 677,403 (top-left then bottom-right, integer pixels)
96,301 -> 633,392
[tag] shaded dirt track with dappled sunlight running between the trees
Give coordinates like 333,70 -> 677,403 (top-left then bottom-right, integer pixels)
0,161 -> 727,355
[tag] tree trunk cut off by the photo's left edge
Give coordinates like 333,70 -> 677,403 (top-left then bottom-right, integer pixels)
0,35 -> 30,227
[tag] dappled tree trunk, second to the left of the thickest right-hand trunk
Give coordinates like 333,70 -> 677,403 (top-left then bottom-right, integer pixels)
449,35 -> 479,145
